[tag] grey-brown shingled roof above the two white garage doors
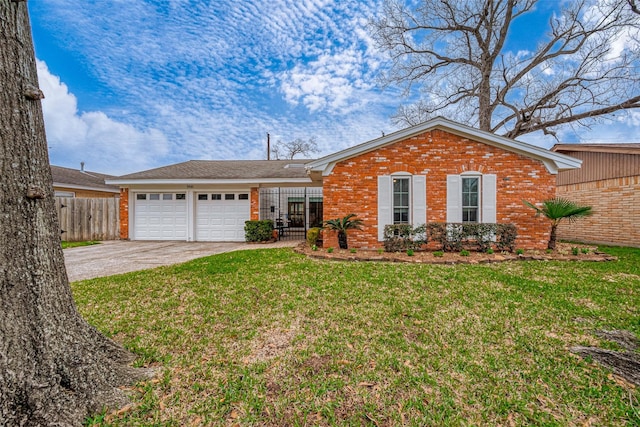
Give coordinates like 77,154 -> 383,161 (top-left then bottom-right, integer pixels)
109,160 -> 310,184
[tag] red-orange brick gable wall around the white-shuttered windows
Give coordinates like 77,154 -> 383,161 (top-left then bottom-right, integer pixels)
323,130 -> 556,249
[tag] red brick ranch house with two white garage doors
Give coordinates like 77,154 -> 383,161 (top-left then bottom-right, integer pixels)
107,118 -> 581,249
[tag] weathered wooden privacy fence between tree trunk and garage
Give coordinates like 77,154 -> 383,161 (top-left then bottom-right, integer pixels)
56,197 -> 120,242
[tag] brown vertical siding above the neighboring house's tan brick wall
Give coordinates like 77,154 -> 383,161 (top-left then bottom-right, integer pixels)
557,151 -> 640,185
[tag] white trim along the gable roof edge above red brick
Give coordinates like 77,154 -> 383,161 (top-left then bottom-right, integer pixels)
307,117 -> 581,176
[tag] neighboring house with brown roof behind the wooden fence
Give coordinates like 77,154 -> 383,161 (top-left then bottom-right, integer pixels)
51,166 -> 120,197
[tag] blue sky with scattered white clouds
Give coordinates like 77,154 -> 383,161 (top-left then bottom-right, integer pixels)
28,0 -> 640,175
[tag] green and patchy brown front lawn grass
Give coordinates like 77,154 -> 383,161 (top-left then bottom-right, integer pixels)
72,248 -> 640,426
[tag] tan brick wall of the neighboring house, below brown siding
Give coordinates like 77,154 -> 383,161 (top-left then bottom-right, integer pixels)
558,175 -> 640,247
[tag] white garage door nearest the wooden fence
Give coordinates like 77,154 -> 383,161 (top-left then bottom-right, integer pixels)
134,193 -> 187,240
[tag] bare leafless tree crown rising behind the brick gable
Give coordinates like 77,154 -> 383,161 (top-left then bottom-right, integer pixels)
371,0 -> 640,138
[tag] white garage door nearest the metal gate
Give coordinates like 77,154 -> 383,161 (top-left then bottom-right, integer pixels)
195,192 -> 251,242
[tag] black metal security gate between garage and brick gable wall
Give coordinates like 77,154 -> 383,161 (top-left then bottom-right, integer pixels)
260,187 -> 322,240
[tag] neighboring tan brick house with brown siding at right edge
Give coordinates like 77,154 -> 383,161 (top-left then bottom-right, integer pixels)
551,144 -> 640,247
